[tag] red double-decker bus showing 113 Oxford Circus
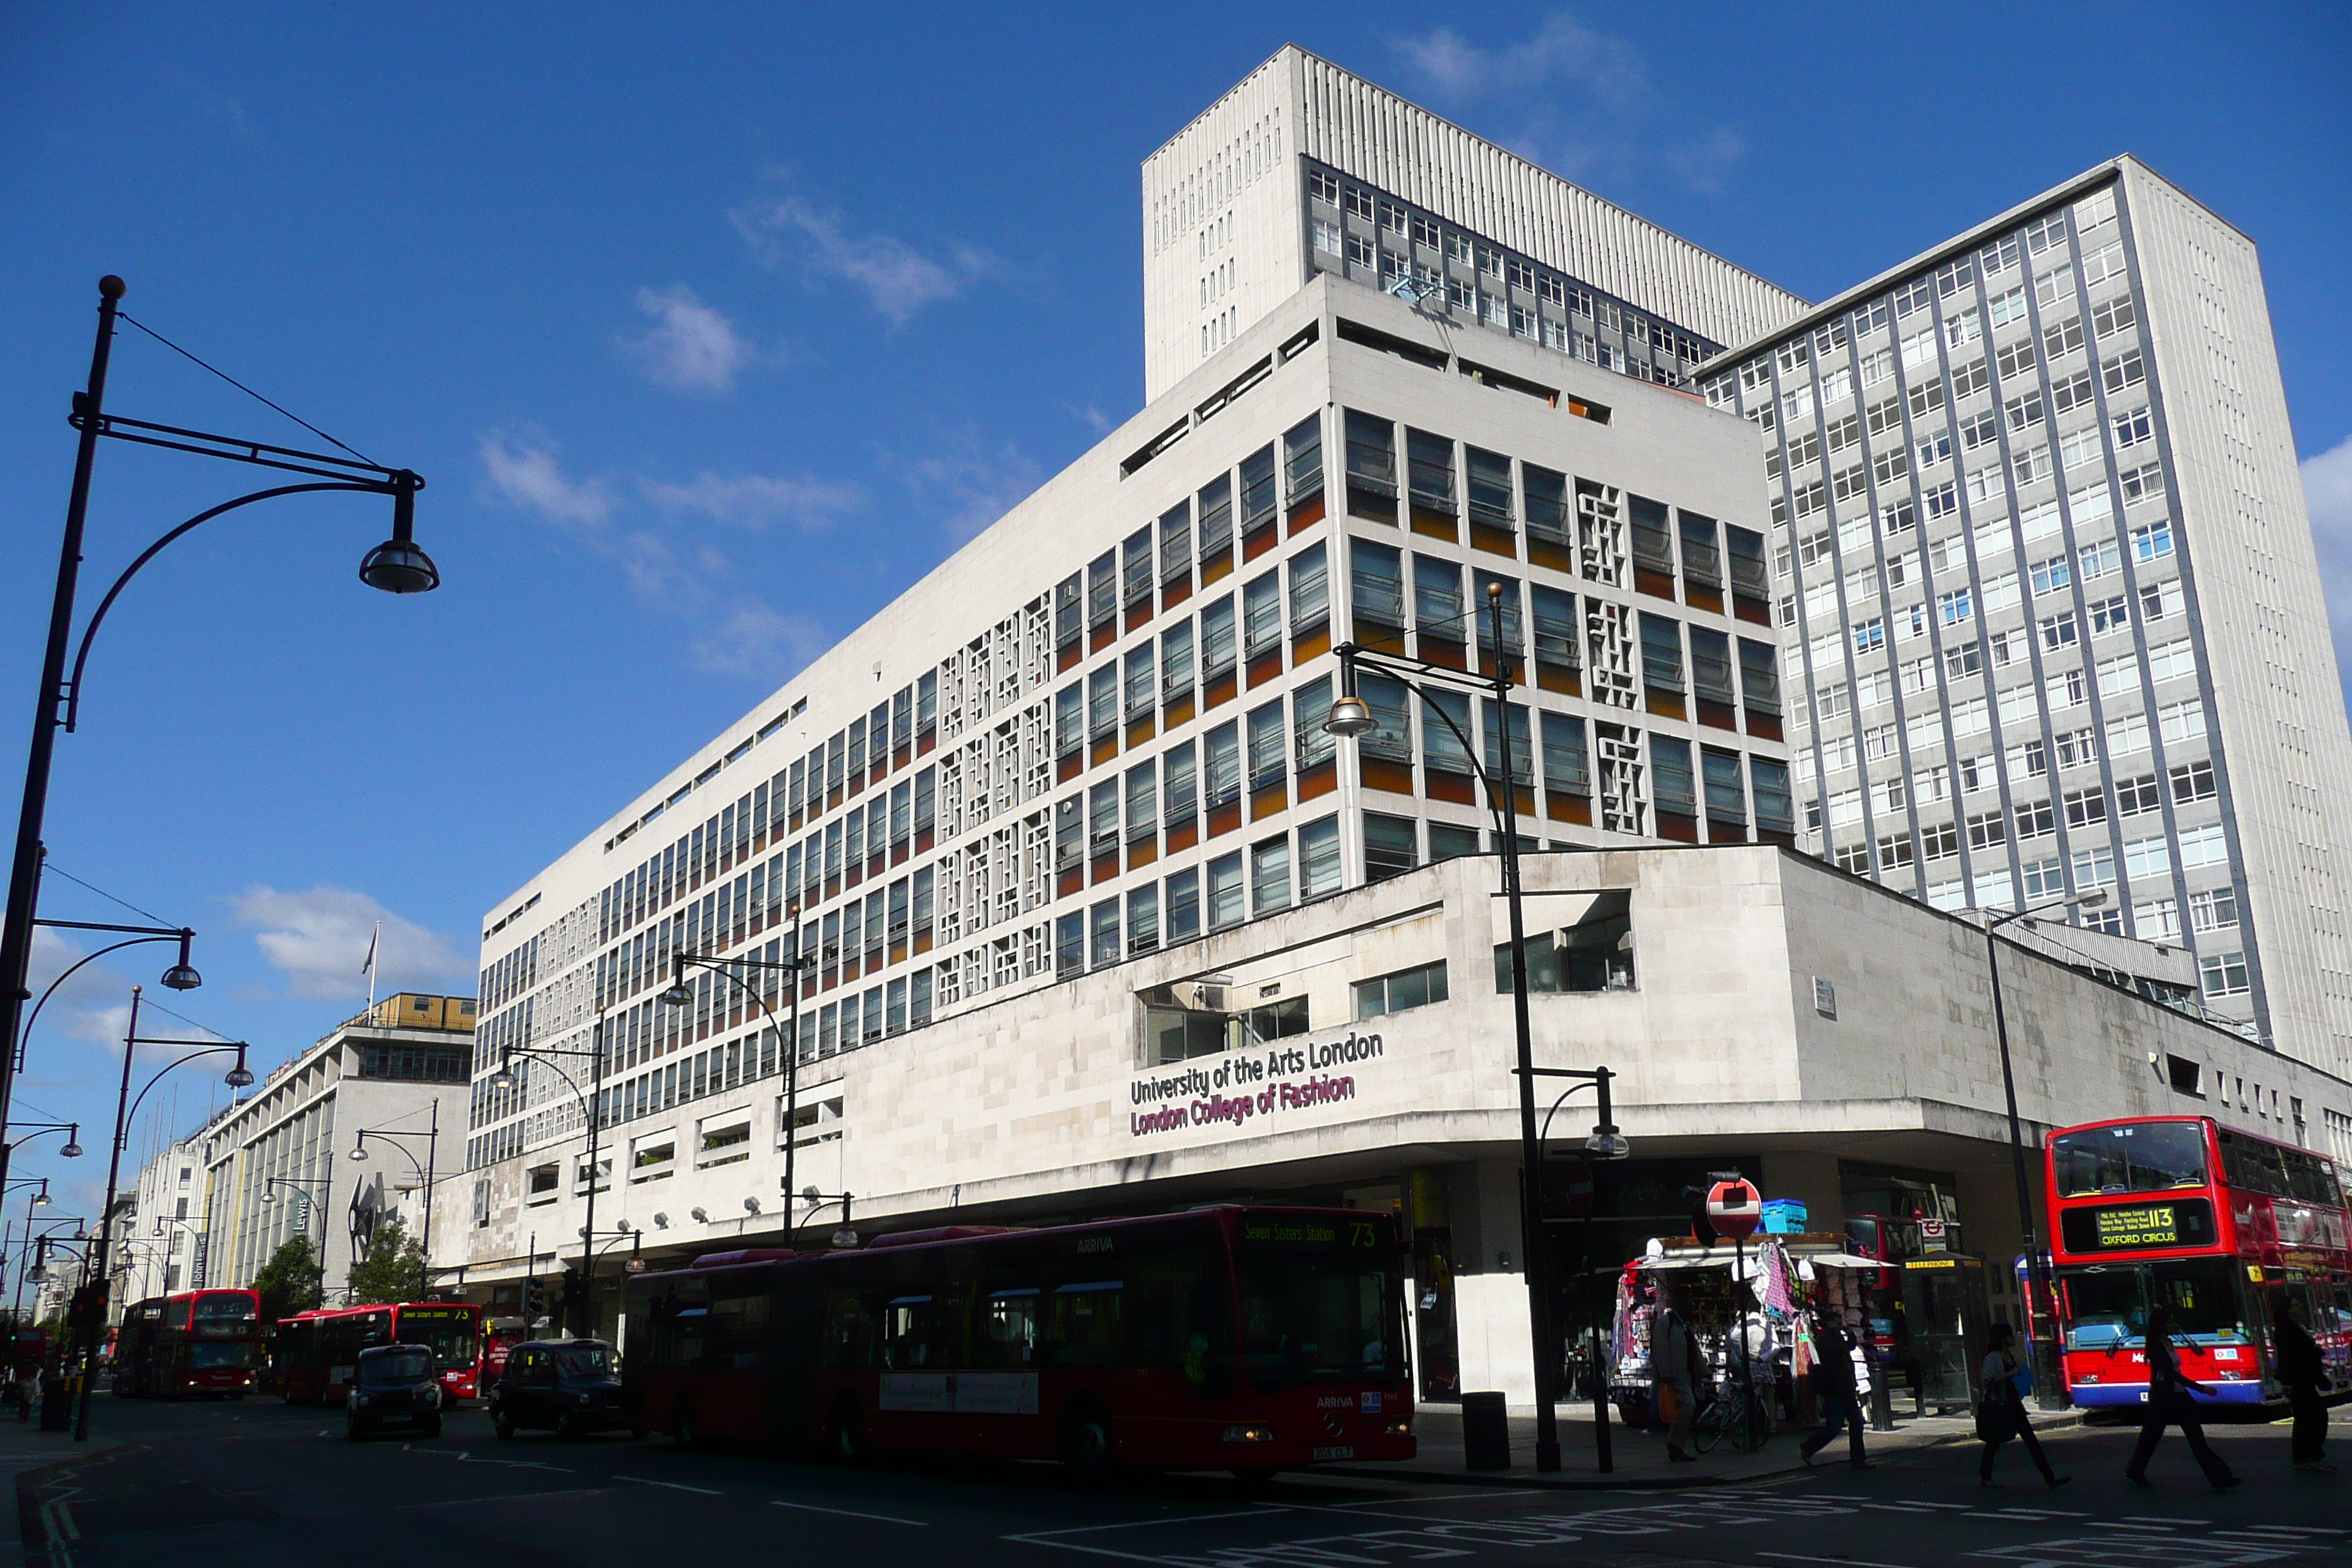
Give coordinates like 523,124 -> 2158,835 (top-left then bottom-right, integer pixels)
2046,1117 -> 2352,1408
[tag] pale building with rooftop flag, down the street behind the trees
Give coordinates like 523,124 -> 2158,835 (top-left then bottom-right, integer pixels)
190,992 -> 472,1303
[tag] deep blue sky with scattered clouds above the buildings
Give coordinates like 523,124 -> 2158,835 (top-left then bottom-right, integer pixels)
0,2 -> 2352,1213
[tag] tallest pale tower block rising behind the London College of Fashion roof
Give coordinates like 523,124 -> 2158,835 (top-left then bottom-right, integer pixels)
1143,45 -> 1804,402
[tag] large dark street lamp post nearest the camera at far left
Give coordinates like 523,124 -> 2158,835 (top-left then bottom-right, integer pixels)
0,275 -> 440,1241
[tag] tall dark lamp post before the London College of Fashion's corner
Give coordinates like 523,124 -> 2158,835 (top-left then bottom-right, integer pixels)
1324,583 -> 1559,1471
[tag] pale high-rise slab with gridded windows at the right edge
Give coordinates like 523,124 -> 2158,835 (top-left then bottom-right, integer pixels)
1705,157 -> 2352,1072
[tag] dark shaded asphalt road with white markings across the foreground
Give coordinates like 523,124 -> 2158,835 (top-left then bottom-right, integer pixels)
0,1399 -> 2352,1568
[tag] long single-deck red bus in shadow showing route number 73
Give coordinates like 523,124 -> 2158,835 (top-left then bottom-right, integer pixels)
623,1208 -> 1414,1477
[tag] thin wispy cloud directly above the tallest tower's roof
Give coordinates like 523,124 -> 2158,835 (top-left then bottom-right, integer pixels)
1392,12 -> 1747,195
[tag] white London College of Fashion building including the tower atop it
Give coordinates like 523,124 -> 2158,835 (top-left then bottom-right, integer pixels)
435,50 -> 2352,1392
